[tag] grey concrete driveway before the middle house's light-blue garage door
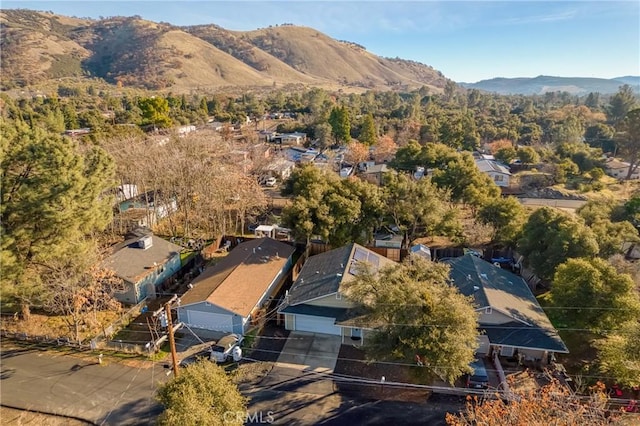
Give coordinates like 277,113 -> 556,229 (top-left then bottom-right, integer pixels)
276,331 -> 342,374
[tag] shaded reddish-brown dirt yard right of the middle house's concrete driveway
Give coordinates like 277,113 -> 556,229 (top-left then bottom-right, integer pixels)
334,345 -> 431,402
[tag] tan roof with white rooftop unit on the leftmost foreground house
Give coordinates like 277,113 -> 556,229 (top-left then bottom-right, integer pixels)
102,234 -> 182,283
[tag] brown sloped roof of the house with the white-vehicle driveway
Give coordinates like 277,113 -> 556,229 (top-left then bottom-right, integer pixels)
180,238 -> 295,317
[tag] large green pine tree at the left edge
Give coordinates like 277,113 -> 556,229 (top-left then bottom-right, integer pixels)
0,122 -> 114,315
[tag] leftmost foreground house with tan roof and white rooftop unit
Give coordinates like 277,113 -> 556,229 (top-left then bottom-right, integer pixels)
102,230 -> 182,304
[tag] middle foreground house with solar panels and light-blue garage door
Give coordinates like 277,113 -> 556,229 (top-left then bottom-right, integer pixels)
278,243 -> 395,344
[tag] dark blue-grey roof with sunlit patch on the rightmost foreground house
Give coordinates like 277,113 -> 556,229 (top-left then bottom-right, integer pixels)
443,254 -> 568,352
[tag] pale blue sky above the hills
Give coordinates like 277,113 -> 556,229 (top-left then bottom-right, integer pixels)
2,0 -> 640,82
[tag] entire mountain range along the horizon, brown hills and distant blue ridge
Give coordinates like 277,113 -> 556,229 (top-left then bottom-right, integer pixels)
0,9 -> 640,95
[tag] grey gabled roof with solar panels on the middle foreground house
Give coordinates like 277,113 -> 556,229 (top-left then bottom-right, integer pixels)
288,243 -> 395,305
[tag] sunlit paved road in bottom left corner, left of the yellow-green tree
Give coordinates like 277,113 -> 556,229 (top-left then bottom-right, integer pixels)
0,348 -> 167,425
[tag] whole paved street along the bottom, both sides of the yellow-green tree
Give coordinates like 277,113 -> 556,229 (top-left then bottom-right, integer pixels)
0,349 -> 463,426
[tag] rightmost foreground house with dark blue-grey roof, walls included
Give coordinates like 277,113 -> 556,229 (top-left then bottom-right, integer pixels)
442,254 -> 569,363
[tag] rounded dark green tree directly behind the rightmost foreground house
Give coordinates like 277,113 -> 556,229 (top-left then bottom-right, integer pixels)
518,207 -> 599,280
